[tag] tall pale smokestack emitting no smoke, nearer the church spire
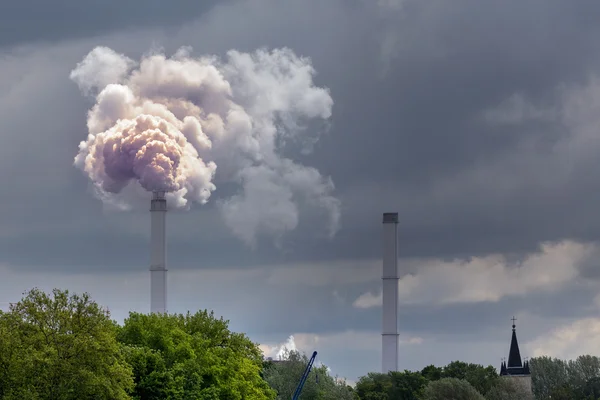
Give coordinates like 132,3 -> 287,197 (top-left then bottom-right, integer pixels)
381,213 -> 400,374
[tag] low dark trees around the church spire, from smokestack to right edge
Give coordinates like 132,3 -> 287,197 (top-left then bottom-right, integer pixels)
355,355 -> 600,400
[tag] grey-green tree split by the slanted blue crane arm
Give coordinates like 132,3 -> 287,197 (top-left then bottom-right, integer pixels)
264,351 -> 356,400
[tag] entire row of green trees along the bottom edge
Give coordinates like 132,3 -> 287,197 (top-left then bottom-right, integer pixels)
0,289 -> 600,400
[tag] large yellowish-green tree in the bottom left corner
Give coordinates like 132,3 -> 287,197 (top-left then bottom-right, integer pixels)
0,289 -> 133,400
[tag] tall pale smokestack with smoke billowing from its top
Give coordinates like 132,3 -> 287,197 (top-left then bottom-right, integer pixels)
150,191 -> 167,313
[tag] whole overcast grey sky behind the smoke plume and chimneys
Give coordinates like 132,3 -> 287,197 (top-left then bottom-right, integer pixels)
0,0 -> 600,380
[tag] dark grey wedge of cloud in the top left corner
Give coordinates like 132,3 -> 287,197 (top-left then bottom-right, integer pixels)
0,0 -> 227,48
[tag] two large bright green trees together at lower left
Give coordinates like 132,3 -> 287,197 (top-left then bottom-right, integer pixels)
0,289 -> 275,400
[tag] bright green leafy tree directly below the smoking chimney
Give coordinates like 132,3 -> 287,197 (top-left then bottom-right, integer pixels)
117,311 -> 275,400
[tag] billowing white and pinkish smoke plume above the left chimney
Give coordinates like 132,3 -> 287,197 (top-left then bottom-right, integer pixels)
70,47 -> 340,245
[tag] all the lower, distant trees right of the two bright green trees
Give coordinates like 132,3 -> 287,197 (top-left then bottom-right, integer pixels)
274,352 -> 600,400
